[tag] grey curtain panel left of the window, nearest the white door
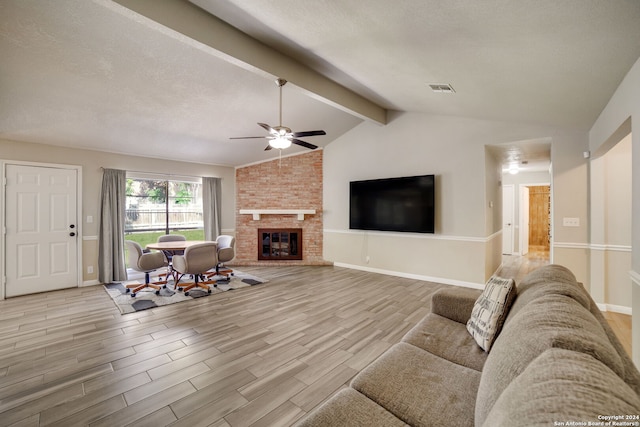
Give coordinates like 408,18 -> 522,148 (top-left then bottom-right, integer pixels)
98,169 -> 127,283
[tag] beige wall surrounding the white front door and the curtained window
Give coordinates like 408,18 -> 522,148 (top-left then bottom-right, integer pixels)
0,140 -> 235,283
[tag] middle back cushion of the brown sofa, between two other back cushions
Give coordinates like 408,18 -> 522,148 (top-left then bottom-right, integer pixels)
476,294 -> 624,423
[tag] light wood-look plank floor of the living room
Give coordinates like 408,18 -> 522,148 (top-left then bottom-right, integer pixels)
0,260 -> 632,427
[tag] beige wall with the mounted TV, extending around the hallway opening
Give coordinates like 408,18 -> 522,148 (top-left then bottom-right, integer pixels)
323,113 -> 587,285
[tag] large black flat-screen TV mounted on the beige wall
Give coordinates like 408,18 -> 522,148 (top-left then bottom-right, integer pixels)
349,175 -> 435,233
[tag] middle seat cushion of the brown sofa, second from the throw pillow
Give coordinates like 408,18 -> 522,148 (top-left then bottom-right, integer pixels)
351,342 -> 480,426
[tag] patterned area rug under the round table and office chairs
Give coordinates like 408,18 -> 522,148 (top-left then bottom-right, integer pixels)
104,270 -> 268,314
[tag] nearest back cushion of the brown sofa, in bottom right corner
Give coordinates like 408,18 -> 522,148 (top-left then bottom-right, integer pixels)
478,349 -> 640,427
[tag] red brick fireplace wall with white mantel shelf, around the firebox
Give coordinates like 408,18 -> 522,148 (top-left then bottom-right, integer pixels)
234,150 -> 326,265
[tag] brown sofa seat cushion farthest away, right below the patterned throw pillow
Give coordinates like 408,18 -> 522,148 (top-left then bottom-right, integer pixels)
402,313 -> 487,371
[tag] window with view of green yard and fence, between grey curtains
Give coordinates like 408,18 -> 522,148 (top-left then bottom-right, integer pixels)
125,174 -> 204,247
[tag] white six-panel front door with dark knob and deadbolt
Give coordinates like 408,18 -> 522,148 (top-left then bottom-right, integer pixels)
5,165 -> 78,297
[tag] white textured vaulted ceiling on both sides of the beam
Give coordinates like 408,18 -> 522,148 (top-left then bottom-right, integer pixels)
0,0 -> 640,165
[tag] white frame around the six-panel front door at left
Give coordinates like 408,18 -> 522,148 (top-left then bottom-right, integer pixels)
0,159 -> 84,300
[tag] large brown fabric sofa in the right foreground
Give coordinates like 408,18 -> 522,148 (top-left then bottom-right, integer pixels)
298,265 -> 640,427
